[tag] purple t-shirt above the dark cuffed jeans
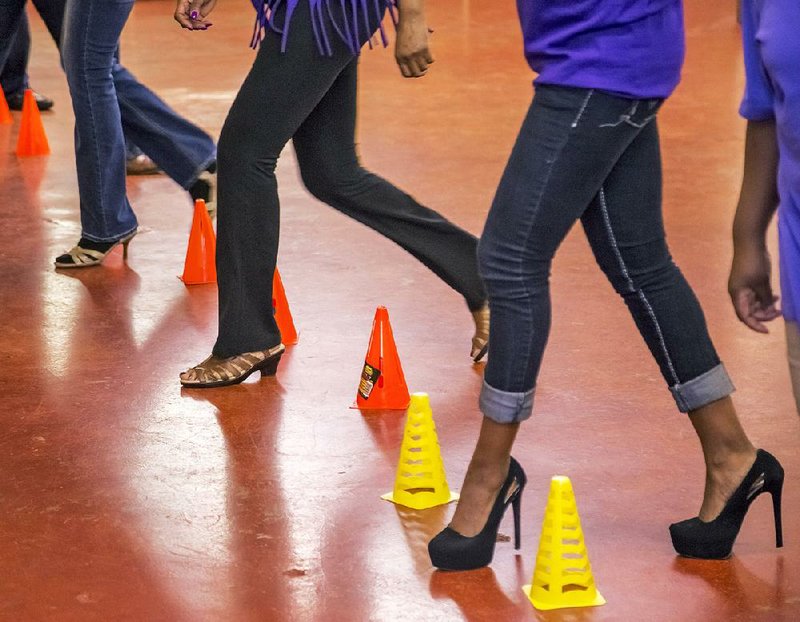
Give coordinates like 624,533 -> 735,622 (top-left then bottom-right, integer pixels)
517,0 -> 688,99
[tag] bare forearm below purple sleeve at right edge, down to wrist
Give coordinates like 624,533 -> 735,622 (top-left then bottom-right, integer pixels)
733,120 -> 778,248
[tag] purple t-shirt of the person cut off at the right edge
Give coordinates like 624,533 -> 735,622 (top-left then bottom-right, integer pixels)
739,0 -> 800,322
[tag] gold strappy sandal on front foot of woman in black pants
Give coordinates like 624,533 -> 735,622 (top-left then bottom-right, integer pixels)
181,343 -> 286,389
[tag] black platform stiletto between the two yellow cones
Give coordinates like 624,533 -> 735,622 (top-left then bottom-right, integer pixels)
428,458 -> 528,570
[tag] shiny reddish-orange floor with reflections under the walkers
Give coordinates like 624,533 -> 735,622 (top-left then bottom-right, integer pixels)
0,0 -> 800,622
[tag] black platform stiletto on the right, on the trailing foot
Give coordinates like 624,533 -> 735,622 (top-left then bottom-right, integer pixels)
669,449 -> 783,559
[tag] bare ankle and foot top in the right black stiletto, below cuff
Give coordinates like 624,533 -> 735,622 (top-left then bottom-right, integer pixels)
689,397 -> 756,521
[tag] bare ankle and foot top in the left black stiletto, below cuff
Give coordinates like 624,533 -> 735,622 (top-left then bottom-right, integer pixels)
450,417 -> 519,537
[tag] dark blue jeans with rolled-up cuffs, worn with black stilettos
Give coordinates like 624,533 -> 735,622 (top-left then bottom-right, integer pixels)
478,85 -> 733,423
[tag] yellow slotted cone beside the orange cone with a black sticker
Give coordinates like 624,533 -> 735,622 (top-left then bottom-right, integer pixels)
381,393 -> 458,510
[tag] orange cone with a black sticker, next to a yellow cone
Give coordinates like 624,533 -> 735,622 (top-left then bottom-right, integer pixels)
354,307 -> 410,410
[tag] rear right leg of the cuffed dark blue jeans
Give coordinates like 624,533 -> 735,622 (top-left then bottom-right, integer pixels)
581,119 -> 733,412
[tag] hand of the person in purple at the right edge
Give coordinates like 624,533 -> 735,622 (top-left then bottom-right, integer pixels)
728,246 -> 781,333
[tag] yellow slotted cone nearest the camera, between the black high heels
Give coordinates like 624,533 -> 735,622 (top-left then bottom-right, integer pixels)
522,475 -> 606,611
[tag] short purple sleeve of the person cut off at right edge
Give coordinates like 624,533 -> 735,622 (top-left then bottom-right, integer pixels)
739,0 -> 775,121
